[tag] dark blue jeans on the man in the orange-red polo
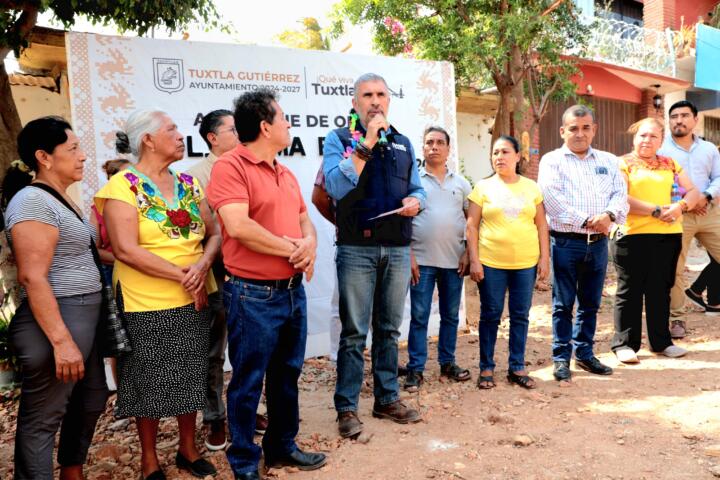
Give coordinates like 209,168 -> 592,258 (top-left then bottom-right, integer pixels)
223,277 -> 307,474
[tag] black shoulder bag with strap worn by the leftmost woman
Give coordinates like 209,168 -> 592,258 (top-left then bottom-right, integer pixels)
31,183 -> 132,357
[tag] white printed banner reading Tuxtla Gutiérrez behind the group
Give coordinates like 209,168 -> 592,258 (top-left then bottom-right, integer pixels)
66,32 -> 464,356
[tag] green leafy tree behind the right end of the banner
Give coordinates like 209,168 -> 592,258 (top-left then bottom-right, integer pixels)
333,0 -> 587,133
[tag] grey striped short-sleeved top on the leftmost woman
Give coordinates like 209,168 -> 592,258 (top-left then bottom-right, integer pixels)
5,187 -> 102,298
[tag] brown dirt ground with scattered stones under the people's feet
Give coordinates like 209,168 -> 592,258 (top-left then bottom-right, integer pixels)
0,246 -> 720,480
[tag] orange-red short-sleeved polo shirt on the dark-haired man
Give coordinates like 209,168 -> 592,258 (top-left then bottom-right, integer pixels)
208,144 -> 307,280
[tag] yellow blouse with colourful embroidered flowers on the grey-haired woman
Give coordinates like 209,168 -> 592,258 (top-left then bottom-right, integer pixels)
95,167 -> 217,312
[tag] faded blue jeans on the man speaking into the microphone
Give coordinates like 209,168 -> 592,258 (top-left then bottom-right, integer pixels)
335,245 -> 410,412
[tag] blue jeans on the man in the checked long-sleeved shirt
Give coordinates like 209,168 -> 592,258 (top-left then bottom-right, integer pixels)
551,237 -> 608,362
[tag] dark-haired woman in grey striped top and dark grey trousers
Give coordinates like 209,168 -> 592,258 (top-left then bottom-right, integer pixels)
2,117 -> 107,480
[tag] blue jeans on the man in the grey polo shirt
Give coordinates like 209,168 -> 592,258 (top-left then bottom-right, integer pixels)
407,265 -> 463,372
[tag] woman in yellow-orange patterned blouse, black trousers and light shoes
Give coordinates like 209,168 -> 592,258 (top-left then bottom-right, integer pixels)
610,118 -> 700,363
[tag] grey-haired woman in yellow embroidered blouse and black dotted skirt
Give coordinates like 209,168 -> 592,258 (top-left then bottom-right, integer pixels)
95,110 -> 220,480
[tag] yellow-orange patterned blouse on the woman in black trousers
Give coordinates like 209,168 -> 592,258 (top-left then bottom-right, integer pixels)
619,155 -> 683,235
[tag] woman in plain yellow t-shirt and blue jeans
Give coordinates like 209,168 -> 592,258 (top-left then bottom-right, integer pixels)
467,135 -> 550,389
